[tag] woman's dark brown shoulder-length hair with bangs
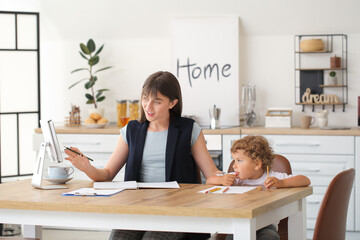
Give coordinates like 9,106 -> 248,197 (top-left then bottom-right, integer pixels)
140,71 -> 182,122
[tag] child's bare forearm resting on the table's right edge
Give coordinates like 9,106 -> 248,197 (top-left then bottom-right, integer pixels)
265,175 -> 311,188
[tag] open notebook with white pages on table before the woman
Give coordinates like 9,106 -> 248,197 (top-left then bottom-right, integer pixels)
94,181 -> 180,189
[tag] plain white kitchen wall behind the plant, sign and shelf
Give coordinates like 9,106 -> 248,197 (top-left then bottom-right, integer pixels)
0,0 -> 360,126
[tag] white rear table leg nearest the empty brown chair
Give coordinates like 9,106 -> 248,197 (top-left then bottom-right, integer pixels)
288,198 -> 306,240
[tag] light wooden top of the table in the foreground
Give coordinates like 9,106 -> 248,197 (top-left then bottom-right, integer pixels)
0,179 -> 312,218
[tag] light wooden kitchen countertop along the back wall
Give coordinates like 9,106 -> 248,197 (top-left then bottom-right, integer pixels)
35,125 -> 360,136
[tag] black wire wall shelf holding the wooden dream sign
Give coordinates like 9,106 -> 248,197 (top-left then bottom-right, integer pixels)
294,34 -> 348,111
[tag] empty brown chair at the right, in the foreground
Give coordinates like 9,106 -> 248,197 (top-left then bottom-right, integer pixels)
313,168 -> 355,240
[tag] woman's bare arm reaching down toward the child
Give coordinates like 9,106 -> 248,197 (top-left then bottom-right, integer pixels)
191,132 -> 235,185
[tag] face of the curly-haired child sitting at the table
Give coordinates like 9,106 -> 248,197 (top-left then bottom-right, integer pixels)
231,150 -> 261,180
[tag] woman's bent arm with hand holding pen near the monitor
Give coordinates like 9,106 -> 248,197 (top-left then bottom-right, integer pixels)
65,135 -> 129,182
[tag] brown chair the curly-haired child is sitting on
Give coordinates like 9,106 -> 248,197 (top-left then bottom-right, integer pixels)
228,154 -> 292,240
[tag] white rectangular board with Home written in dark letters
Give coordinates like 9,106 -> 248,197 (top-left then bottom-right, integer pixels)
171,17 -> 239,125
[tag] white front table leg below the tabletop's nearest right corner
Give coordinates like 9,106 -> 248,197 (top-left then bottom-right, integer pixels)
233,218 -> 256,240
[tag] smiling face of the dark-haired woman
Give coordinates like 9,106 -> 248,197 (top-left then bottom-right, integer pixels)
141,91 -> 178,122
